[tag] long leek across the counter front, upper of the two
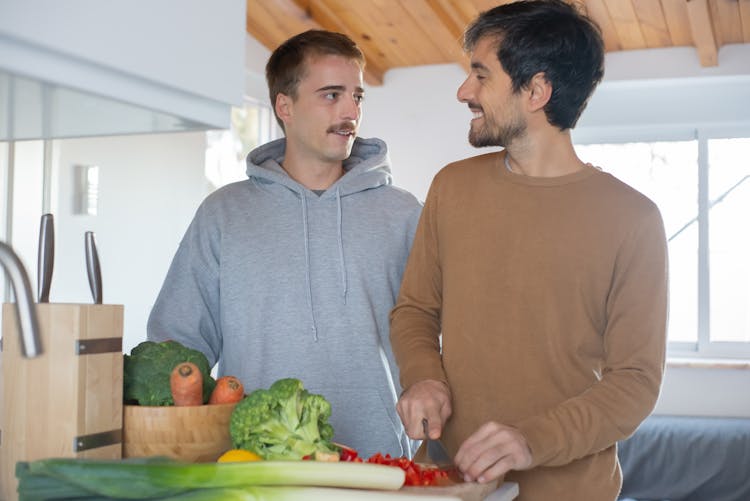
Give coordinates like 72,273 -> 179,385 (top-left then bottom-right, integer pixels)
16,458 -> 405,501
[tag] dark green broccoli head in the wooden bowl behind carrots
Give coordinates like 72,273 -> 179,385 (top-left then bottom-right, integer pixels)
123,341 -> 216,405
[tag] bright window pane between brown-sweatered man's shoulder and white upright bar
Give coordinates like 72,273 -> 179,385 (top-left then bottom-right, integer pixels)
576,141 -> 698,343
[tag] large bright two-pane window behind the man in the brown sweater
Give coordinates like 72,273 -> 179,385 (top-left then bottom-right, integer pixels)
576,133 -> 750,357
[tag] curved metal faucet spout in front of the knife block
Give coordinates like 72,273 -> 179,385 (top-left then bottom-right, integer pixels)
0,242 -> 42,358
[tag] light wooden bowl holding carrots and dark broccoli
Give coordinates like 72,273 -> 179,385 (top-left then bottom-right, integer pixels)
122,404 -> 237,463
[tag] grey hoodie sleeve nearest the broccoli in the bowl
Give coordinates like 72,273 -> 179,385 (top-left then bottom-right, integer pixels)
147,203 -> 221,366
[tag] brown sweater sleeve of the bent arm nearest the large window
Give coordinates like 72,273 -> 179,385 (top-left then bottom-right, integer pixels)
516,202 -> 668,466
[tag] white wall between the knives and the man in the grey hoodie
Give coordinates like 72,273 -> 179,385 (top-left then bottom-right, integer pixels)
52,132 -> 209,353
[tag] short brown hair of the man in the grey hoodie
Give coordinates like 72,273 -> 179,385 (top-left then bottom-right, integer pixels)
266,30 -> 365,129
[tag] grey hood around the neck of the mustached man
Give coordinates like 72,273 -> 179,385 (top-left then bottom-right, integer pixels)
247,137 -> 393,197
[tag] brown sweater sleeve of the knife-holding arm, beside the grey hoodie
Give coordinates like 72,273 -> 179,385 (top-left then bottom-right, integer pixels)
390,174 -> 447,389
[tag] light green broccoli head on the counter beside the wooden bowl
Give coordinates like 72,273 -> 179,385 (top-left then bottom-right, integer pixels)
229,378 -> 337,460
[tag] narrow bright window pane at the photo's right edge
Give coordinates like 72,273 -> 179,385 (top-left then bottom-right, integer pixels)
708,138 -> 750,342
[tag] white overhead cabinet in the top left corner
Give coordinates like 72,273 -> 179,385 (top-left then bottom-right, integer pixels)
0,0 -> 246,130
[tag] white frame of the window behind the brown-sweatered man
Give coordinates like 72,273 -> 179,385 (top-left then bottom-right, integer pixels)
573,124 -> 750,359
